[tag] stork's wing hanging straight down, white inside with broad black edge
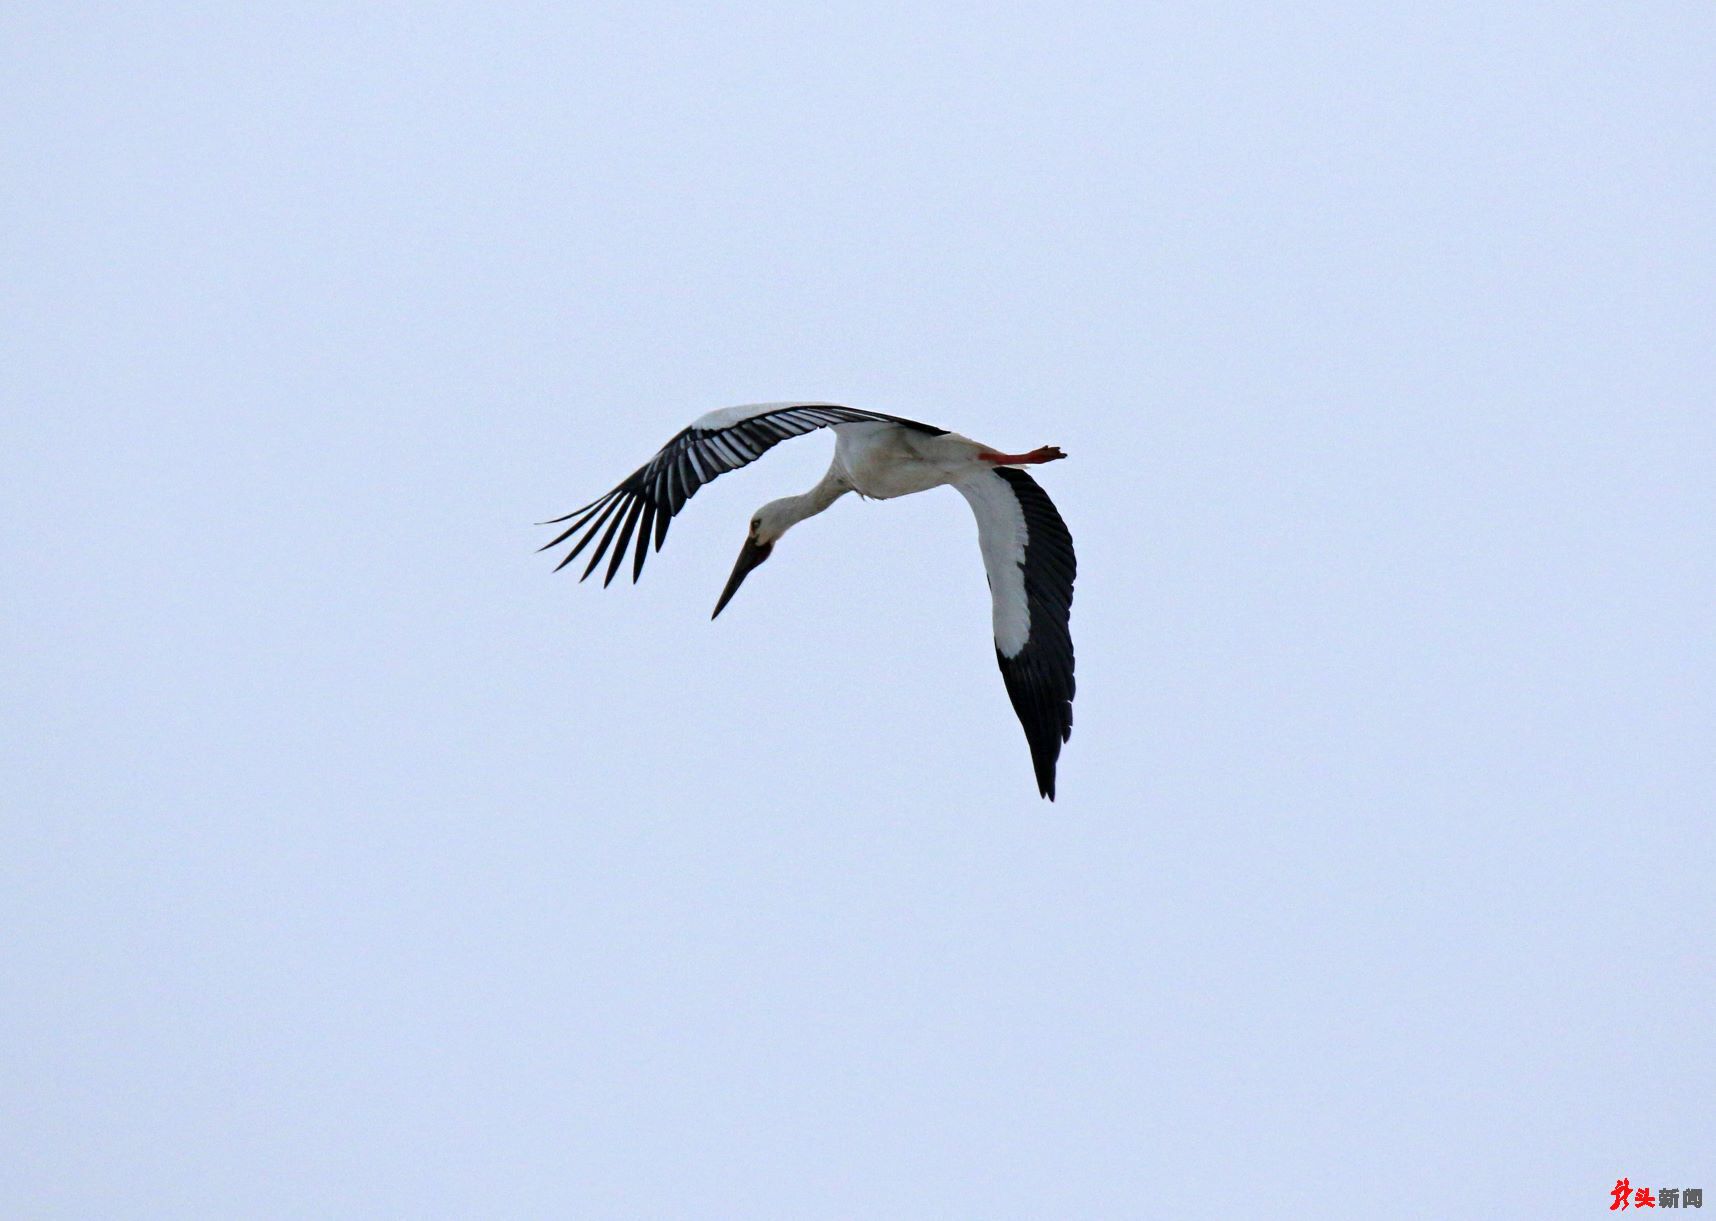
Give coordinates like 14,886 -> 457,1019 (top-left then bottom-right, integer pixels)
954,466 -> 1078,801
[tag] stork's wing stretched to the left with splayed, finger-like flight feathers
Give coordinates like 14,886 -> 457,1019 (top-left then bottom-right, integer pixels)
539,403 -> 946,585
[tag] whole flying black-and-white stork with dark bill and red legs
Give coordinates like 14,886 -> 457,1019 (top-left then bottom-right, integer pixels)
542,403 -> 1076,801
